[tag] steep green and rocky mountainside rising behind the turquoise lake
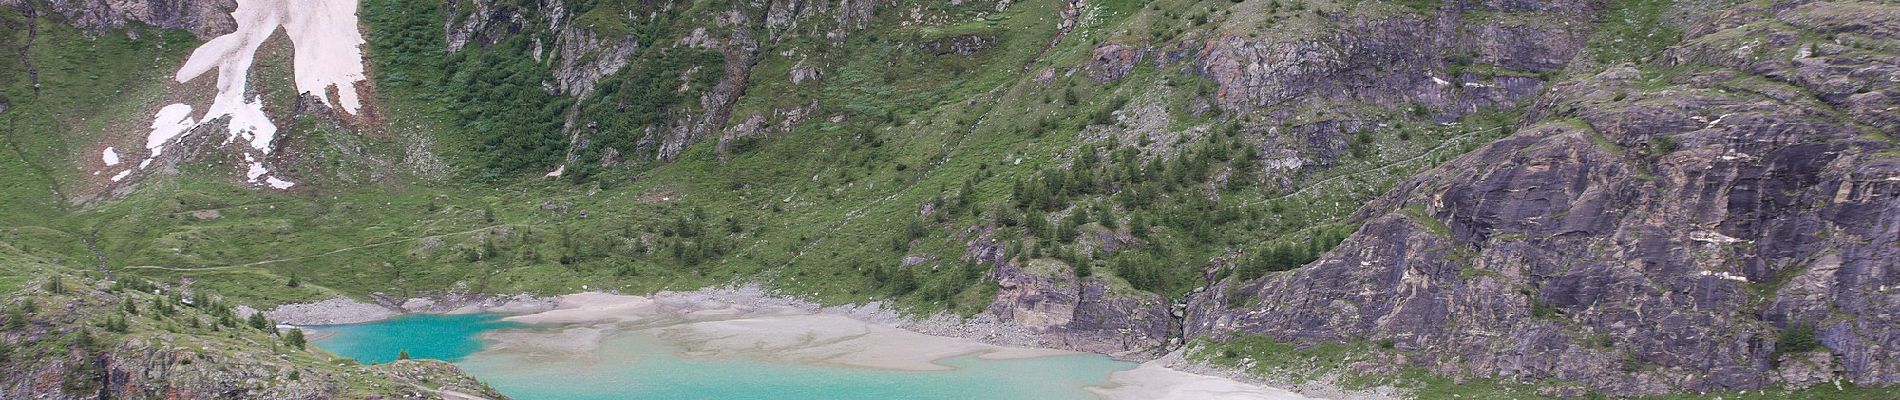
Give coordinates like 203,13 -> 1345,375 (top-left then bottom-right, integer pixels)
0,0 -> 1900,396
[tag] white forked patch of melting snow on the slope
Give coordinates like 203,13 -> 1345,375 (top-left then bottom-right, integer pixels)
122,0 -> 365,190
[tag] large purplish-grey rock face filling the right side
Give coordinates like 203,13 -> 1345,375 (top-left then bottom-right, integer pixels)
1186,2 -> 1900,394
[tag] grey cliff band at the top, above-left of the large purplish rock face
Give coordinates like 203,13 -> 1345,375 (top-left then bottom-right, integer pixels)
1185,0 -> 1590,116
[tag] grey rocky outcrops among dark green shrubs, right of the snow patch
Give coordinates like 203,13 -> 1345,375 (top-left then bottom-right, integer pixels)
445,0 -> 775,163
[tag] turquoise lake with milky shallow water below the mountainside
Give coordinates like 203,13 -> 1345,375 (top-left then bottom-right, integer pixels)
314,315 -> 1134,400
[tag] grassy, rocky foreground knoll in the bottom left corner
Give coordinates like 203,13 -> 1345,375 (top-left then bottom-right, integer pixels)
0,243 -> 505,400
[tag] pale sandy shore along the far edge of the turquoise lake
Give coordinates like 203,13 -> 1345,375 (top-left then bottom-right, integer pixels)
281,286 -> 1330,400
